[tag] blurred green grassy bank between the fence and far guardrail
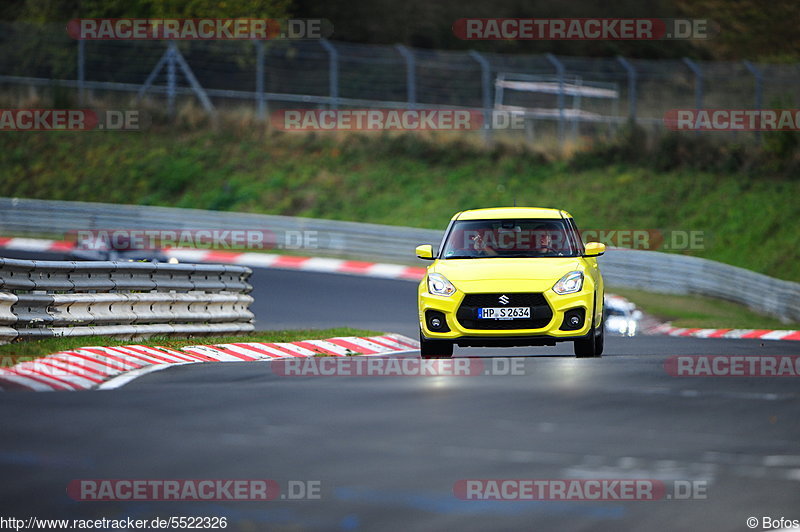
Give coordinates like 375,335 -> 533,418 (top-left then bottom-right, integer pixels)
0,127 -> 800,280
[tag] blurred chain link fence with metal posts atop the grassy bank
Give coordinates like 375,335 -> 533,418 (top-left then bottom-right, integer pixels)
0,23 -> 800,140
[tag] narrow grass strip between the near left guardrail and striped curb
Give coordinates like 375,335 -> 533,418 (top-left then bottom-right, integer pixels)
0,327 -> 385,367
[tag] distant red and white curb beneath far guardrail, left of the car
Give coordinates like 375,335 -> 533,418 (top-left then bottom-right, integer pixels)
0,237 -> 425,281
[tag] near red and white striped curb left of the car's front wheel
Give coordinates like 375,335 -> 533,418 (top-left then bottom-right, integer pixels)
0,334 -> 419,391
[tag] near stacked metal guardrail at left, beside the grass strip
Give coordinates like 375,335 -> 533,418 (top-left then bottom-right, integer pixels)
0,258 -> 254,343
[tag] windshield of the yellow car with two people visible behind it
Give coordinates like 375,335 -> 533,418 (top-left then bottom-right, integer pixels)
441,219 -> 580,259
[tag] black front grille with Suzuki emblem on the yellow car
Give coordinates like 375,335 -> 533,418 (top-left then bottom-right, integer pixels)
456,292 -> 553,330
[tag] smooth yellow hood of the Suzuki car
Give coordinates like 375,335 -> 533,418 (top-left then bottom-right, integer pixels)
430,257 -> 583,283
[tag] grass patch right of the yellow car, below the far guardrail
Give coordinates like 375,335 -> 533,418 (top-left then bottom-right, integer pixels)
609,288 -> 800,329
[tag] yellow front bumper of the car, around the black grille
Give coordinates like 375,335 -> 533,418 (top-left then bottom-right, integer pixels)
419,282 -> 595,346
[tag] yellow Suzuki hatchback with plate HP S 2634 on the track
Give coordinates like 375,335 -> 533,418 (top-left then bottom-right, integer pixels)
417,207 -> 605,358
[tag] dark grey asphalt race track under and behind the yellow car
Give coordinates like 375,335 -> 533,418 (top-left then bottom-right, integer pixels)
0,250 -> 800,531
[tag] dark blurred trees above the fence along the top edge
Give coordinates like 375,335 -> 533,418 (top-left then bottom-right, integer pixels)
0,0 -> 800,63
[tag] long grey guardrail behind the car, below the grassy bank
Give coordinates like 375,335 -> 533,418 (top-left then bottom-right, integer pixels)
0,198 -> 800,321
